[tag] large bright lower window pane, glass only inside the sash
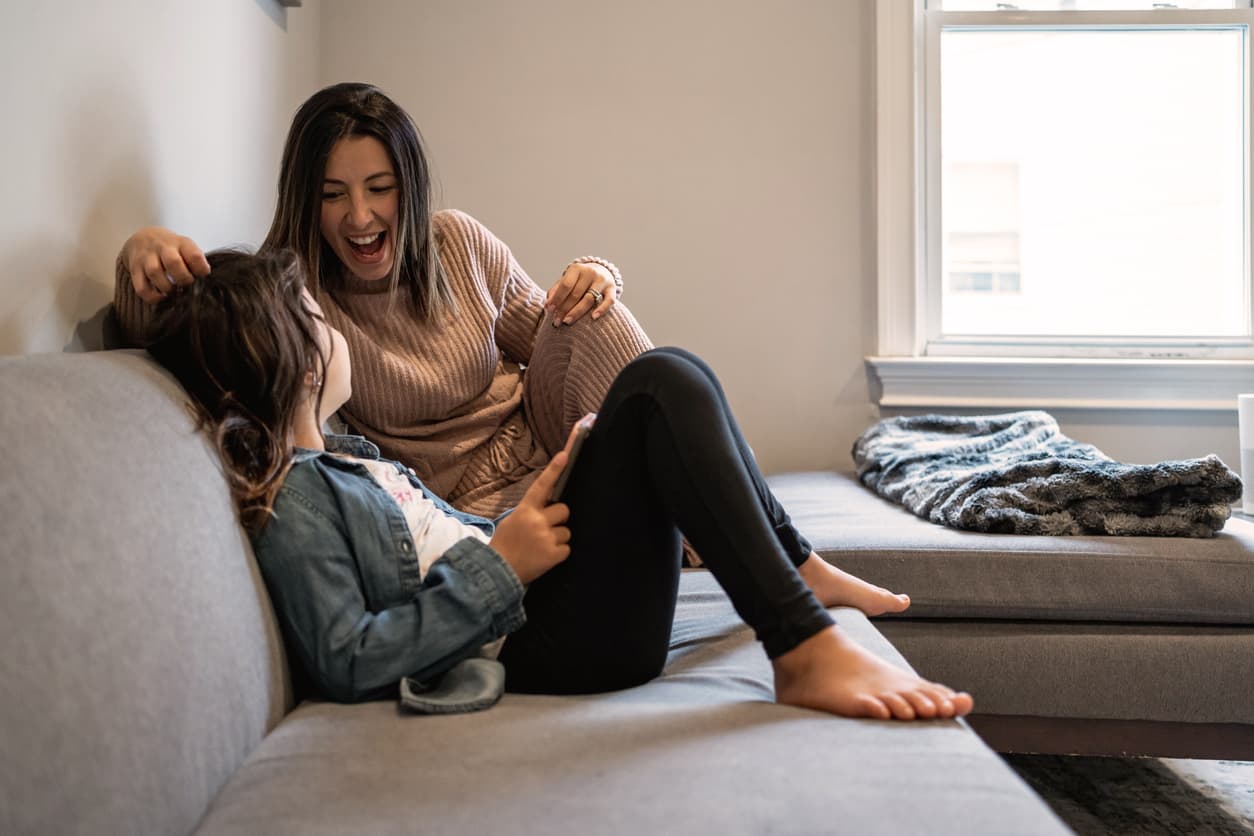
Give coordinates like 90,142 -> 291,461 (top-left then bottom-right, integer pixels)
941,28 -> 1249,337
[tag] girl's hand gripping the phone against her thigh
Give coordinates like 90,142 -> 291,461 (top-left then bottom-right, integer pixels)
492,450 -> 571,584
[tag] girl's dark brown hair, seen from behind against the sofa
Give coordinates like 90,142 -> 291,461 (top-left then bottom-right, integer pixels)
148,249 -> 334,533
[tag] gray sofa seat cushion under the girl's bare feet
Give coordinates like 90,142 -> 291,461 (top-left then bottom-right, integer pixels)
198,572 -> 1067,836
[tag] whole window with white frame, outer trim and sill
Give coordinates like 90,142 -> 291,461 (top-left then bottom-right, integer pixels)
868,0 -> 1254,411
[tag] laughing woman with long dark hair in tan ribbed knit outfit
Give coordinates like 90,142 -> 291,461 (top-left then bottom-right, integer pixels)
114,84 -> 651,516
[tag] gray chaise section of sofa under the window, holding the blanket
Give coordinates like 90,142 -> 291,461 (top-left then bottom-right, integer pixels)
771,473 -> 1254,760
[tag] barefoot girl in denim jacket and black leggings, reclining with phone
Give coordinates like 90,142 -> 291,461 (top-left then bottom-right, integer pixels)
149,251 -> 972,719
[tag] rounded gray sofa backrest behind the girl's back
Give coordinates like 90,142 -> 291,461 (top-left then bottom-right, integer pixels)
0,351 -> 292,833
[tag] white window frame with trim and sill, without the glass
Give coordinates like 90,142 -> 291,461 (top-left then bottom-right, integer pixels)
868,0 -> 1254,410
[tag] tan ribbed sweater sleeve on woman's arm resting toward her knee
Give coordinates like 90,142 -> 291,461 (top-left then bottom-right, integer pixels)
438,209 -> 544,363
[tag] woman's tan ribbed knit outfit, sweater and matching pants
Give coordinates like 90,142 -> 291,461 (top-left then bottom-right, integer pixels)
114,211 -> 652,516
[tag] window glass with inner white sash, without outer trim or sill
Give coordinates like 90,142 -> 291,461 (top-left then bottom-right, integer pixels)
914,0 -> 1254,358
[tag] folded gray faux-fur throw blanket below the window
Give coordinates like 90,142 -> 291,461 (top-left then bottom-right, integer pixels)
853,411 -> 1241,536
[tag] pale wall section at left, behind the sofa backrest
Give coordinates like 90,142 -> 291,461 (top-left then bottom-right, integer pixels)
0,0 -> 319,355
